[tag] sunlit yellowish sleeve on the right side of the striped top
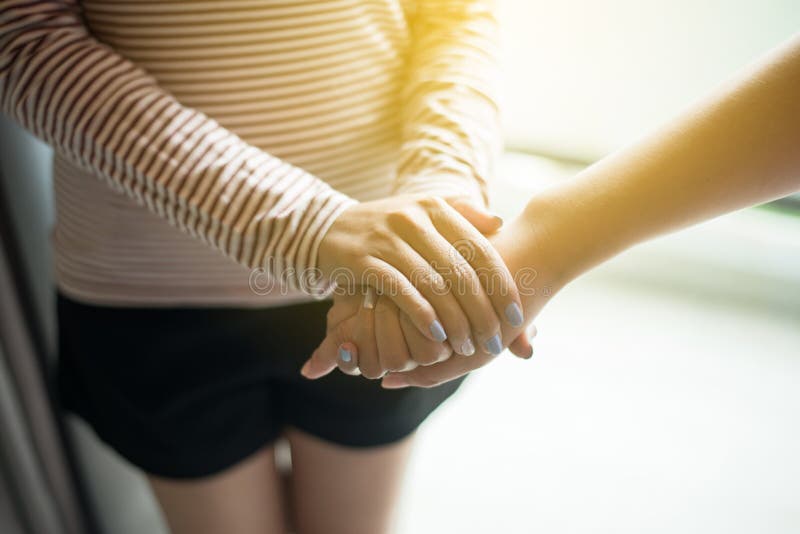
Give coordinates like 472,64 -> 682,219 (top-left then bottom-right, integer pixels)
395,0 -> 501,207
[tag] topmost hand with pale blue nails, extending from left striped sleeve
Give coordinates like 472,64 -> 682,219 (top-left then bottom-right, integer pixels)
318,195 -> 523,356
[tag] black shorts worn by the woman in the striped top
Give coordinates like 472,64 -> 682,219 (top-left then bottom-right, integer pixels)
58,296 -> 461,478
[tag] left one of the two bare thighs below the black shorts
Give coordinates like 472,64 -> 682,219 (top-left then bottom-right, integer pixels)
148,447 -> 286,534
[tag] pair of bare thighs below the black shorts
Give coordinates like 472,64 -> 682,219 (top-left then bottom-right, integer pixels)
148,429 -> 413,534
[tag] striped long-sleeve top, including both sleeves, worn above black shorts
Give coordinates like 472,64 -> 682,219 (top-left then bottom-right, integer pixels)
0,0 -> 499,305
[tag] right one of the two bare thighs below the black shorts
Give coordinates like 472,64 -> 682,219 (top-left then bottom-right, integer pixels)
286,429 -> 413,534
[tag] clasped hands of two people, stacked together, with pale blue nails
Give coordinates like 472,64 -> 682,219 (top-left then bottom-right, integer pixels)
310,196 -> 532,388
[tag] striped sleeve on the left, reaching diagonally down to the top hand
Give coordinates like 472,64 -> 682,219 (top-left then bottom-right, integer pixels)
0,0 -> 355,294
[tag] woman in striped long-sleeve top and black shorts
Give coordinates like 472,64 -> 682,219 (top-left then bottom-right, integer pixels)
0,0 -> 522,534
